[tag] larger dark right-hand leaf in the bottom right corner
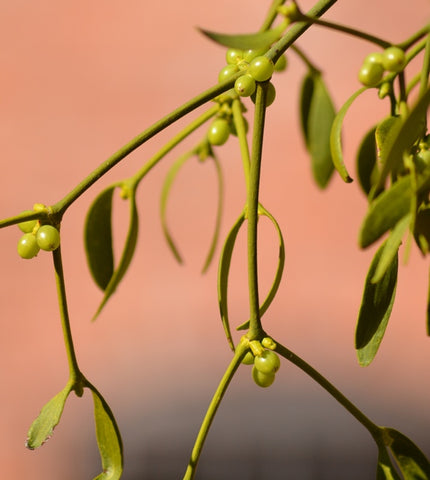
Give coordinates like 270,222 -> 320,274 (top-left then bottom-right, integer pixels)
384,428 -> 430,480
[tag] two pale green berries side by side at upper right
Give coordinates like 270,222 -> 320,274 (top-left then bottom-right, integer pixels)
358,47 -> 406,87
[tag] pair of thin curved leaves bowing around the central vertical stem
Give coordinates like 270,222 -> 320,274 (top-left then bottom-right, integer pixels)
218,204 -> 285,351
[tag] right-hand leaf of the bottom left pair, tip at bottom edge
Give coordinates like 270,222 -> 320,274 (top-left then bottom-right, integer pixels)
90,385 -> 123,480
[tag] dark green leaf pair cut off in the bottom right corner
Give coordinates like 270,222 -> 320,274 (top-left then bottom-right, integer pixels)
376,427 -> 430,480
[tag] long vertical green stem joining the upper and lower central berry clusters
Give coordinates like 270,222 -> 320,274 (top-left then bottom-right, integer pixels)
246,83 -> 267,340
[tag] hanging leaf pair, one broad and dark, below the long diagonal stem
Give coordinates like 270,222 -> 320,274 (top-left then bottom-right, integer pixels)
84,184 -> 139,320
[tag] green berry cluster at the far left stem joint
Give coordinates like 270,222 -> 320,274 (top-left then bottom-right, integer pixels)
17,211 -> 60,259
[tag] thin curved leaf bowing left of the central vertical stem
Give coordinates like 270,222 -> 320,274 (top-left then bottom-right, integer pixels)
218,212 -> 245,351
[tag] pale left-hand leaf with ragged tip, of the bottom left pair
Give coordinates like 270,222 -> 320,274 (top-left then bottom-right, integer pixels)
26,383 -> 72,450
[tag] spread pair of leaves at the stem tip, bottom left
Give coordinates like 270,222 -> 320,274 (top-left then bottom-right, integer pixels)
26,381 -> 123,480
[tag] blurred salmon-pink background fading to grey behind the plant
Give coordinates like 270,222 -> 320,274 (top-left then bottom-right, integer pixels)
0,0 -> 430,480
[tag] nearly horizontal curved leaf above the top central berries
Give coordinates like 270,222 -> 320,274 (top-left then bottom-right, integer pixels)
199,22 -> 287,50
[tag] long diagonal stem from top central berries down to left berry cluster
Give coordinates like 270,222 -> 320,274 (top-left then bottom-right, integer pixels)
52,81 -> 236,216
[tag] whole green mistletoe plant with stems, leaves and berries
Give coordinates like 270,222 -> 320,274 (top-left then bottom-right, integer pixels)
0,0 -> 430,480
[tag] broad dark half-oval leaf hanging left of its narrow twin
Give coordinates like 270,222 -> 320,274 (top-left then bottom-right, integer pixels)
84,185 -> 116,290
